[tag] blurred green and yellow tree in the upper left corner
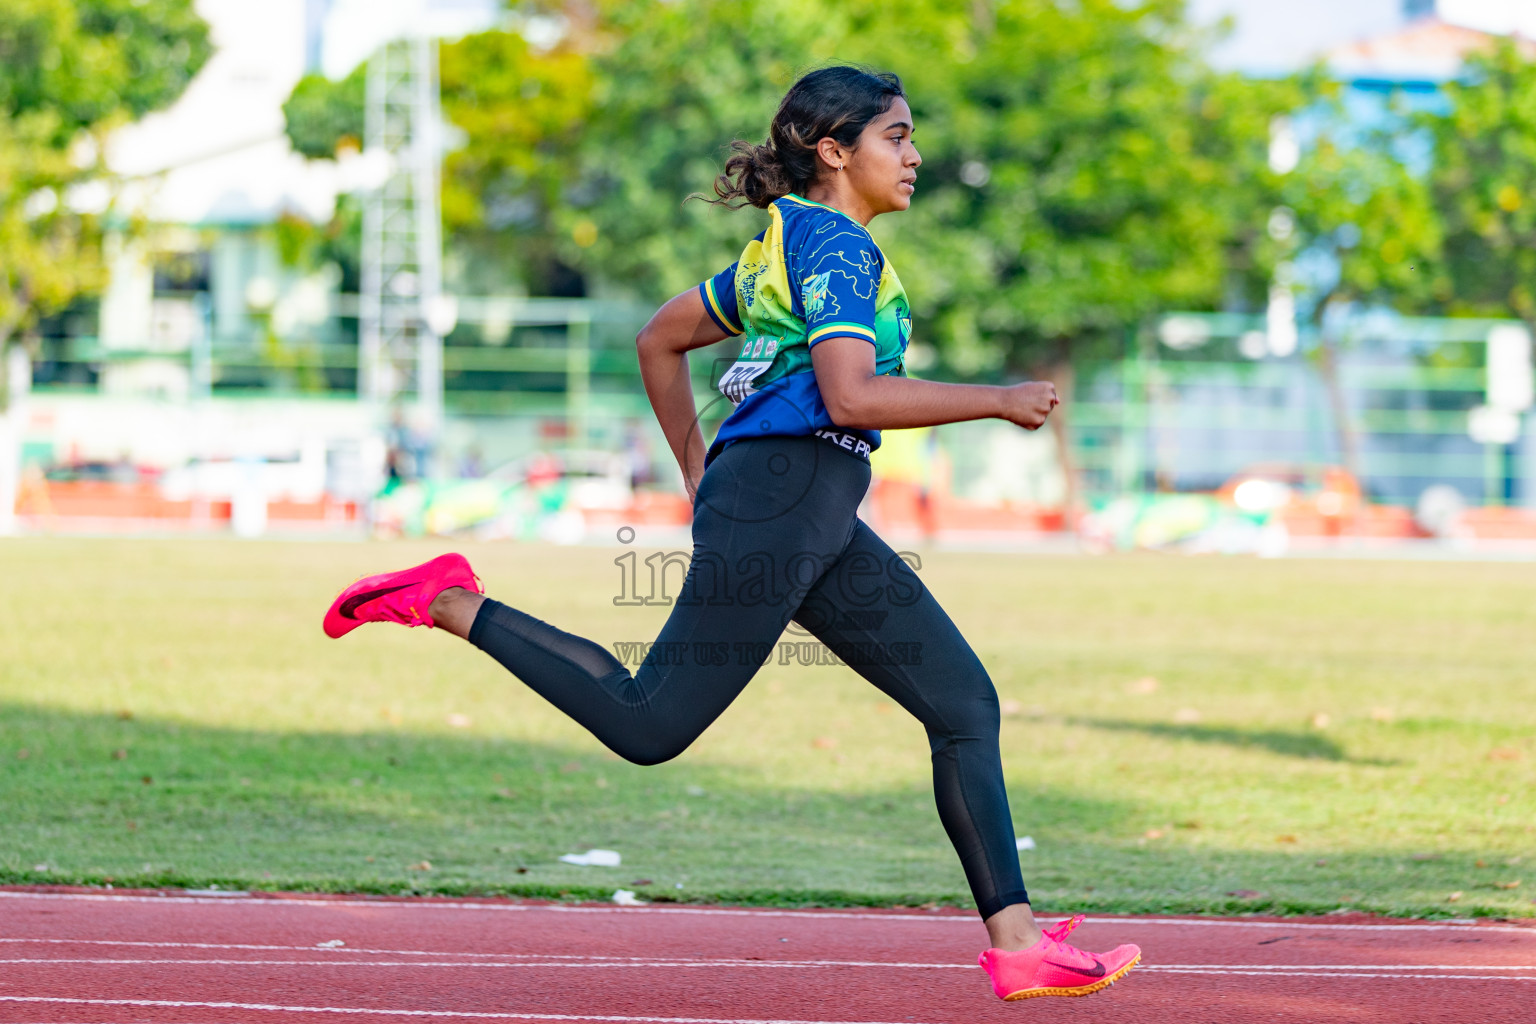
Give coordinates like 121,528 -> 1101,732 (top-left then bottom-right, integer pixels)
0,0 -> 212,376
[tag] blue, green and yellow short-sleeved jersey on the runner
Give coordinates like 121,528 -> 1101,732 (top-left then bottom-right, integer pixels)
699,195 -> 912,465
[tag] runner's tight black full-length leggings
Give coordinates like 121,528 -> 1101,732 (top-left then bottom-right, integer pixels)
468,438 -> 1029,918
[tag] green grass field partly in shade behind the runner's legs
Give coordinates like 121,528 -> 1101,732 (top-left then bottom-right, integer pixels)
0,540 -> 1536,917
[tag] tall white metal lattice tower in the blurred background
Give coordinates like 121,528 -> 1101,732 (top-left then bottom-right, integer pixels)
358,35 -> 449,430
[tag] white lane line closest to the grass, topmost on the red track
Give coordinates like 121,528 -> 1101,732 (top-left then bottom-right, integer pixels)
0,890 -> 1536,938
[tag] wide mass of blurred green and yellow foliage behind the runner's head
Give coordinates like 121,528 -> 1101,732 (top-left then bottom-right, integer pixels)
442,0 -> 1295,373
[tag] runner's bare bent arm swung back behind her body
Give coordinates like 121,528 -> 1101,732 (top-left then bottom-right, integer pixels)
634,289 -> 730,500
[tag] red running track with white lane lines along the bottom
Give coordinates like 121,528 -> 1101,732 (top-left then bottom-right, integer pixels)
0,890 -> 1536,1024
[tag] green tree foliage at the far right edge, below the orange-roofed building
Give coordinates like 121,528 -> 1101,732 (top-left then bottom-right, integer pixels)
1424,41 -> 1536,321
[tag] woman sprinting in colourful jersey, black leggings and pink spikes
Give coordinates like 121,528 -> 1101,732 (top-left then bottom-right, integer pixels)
324,66 -> 1141,999
